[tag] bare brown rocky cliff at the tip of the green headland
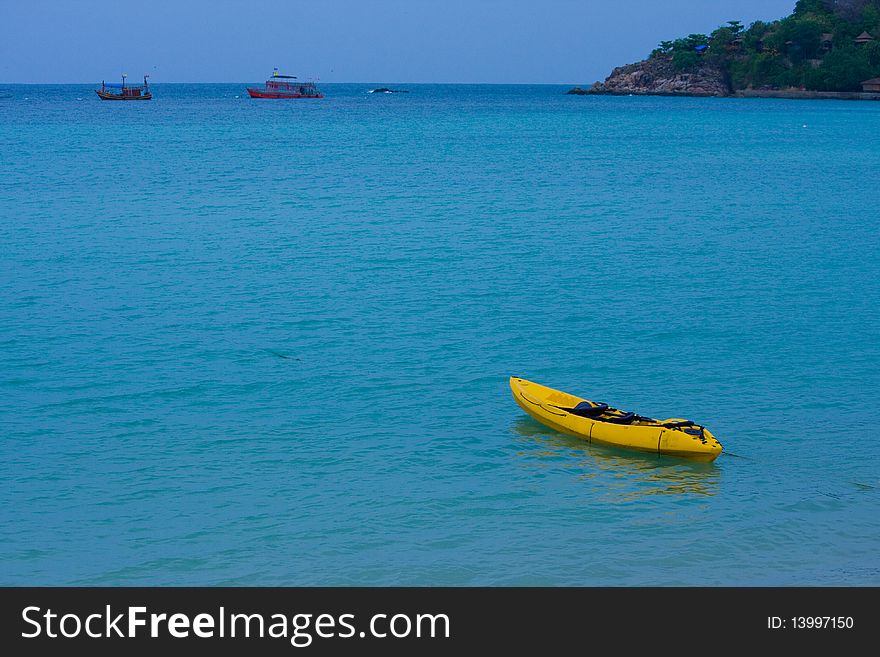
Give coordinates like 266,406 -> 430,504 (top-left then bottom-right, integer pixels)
590,55 -> 730,96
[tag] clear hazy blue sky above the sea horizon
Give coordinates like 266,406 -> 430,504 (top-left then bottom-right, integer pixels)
0,0 -> 795,84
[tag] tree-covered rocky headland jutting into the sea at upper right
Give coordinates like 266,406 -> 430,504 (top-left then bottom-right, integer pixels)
568,0 -> 880,100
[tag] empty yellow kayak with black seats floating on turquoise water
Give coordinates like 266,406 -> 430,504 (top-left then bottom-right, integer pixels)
510,376 -> 721,461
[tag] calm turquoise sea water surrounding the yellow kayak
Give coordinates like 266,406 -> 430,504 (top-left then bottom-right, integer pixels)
0,84 -> 880,586
